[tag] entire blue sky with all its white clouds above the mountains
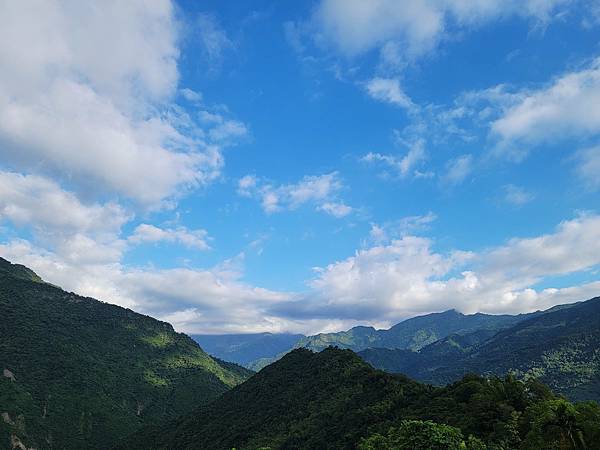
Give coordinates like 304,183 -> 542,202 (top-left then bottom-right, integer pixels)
0,0 -> 600,334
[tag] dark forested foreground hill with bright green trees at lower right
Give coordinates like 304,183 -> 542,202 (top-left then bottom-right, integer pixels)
116,348 -> 600,450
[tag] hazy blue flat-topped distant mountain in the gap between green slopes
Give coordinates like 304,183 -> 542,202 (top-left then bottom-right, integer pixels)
190,333 -> 304,367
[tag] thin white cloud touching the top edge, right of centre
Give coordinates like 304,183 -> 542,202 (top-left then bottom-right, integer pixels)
310,0 -> 570,59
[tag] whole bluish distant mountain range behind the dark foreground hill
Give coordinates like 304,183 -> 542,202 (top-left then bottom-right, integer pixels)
192,299 -> 600,400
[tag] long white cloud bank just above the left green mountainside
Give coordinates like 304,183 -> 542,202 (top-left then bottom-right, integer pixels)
0,167 -> 301,332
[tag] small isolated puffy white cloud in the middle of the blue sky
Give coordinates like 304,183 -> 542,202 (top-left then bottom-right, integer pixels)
238,172 -> 352,218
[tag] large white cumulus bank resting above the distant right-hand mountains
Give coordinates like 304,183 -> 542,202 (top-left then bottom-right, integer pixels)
279,215 -> 600,323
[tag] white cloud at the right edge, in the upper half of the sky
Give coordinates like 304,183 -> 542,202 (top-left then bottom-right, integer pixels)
491,59 -> 600,158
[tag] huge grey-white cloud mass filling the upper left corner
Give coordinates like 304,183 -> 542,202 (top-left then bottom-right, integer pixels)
0,0 -> 242,207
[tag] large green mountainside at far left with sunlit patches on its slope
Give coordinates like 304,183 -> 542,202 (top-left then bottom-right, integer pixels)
0,258 -> 251,450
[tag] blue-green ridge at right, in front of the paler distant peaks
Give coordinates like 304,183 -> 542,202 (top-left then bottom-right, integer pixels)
360,297 -> 600,400
